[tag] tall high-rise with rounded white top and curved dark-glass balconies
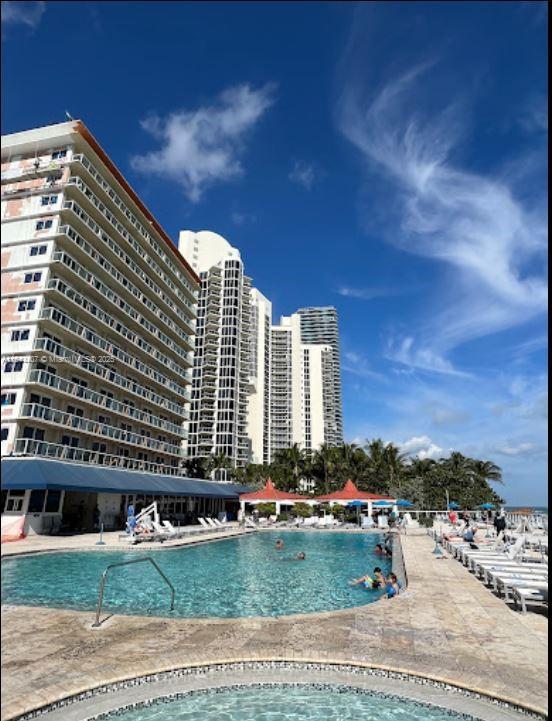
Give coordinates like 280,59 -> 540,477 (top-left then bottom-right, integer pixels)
179,231 -> 255,470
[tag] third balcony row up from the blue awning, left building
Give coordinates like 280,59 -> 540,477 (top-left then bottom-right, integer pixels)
27,369 -> 188,438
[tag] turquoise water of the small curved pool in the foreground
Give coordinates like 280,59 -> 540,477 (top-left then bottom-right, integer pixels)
96,686 -> 469,721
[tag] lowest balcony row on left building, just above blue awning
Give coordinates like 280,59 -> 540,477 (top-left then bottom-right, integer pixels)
13,438 -> 182,476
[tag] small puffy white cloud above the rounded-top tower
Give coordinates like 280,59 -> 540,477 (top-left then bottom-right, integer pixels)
131,83 -> 275,203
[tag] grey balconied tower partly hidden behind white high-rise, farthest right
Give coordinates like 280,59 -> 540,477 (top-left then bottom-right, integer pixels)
297,306 -> 343,445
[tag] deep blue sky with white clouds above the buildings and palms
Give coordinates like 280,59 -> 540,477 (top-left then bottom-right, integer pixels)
2,2 -> 548,504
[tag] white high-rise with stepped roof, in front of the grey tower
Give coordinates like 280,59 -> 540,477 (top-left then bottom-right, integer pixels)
270,313 -> 334,459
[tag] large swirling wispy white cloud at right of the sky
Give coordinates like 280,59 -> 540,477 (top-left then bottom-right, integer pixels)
338,52 -> 547,373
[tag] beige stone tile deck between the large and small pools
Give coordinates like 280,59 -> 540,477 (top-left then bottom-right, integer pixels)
2,530 -> 548,720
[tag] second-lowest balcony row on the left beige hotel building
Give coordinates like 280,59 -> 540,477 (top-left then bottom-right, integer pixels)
21,403 -> 183,457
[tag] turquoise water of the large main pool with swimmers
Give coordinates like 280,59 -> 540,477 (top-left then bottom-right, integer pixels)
2,531 -> 391,618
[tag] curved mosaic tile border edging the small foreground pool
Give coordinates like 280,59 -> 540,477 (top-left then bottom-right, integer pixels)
10,660 -> 547,721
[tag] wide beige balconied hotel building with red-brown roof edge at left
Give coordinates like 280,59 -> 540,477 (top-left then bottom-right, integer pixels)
2,121 -> 199,475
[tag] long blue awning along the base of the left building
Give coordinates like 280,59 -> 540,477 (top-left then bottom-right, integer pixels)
2,458 -> 251,500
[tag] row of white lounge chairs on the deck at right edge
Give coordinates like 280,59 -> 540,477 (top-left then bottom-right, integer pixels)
436,534 -> 548,613
